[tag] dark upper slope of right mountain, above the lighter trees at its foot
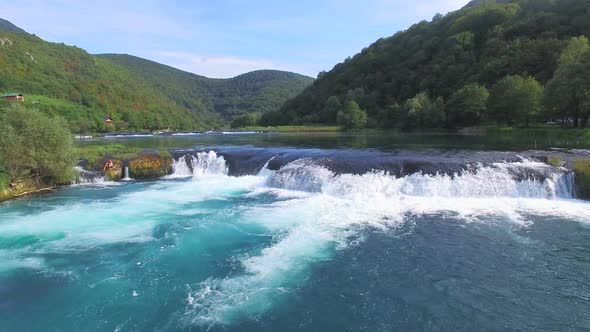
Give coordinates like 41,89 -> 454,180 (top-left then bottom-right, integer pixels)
278,0 -> 590,127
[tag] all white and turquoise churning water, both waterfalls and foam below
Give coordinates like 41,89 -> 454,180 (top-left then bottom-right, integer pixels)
0,151 -> 590,328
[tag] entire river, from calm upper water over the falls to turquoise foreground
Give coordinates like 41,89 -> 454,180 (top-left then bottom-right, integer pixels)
0,134 -> 590,331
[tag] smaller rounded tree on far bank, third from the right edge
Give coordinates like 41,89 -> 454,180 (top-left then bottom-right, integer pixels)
446,83 -> 490,126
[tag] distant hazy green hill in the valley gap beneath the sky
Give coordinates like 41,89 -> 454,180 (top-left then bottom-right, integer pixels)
98,54 -> 313,120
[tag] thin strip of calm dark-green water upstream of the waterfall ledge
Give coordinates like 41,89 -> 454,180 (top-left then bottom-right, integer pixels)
78,131 -> 588,150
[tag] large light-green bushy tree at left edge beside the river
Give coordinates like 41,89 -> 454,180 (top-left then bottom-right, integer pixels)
0,108 -> 75,184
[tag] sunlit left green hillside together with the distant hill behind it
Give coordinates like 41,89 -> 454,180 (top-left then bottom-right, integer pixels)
0,20 -> 312,133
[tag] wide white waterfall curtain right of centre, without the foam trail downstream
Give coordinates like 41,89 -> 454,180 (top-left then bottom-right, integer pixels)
267,159 -> 574,199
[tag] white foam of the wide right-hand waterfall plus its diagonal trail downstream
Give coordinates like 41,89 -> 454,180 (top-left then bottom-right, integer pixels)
184,161 -> 590,325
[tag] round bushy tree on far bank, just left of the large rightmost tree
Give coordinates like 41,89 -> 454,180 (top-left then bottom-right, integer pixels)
488,75 -> 543,127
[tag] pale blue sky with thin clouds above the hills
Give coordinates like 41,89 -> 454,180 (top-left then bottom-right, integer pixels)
0,0 -> 469,77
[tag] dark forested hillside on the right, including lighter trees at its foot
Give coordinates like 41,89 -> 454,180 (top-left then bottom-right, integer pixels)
272,0 -> 590,129
